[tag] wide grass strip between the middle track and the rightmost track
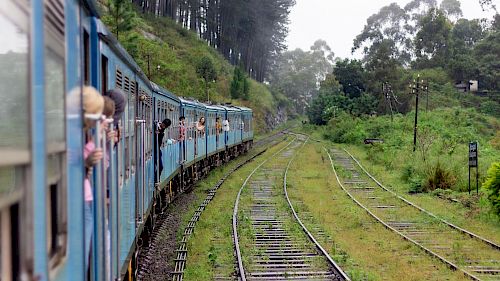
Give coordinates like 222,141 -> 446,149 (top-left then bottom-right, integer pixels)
288,144 -> 467,280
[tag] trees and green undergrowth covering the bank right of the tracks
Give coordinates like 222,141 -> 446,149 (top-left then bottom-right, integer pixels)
307,0 -> 500,217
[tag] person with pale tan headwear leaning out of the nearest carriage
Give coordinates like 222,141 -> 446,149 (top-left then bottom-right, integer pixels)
82,86 -> 104,274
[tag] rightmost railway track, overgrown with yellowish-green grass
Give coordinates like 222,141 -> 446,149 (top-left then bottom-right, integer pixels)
325,149 -> 500,281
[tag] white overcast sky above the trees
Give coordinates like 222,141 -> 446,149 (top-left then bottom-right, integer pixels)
286,0 -> 500,58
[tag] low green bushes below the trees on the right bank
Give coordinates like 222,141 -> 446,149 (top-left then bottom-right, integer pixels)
318,107 -> 500,192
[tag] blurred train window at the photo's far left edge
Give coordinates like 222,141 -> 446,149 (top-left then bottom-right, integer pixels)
0,0 -> 32,281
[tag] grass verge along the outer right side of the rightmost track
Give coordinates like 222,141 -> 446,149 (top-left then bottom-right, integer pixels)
346,145 -> 500,244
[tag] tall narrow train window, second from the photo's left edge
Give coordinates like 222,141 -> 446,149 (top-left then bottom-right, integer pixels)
44,0 -> 67,268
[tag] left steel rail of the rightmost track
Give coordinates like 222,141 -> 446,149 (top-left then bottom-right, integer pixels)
323,147 -> 481,281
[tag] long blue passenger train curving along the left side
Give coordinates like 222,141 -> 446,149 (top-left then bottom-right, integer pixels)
0,0 -> 253,281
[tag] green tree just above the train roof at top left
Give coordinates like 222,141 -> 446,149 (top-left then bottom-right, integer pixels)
103,0 -> 137,39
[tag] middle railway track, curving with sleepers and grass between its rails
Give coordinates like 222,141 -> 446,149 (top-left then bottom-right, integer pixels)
233,136 -> 349,281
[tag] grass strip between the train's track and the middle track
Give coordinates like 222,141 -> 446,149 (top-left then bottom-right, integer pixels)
178,135 -> 292,281
